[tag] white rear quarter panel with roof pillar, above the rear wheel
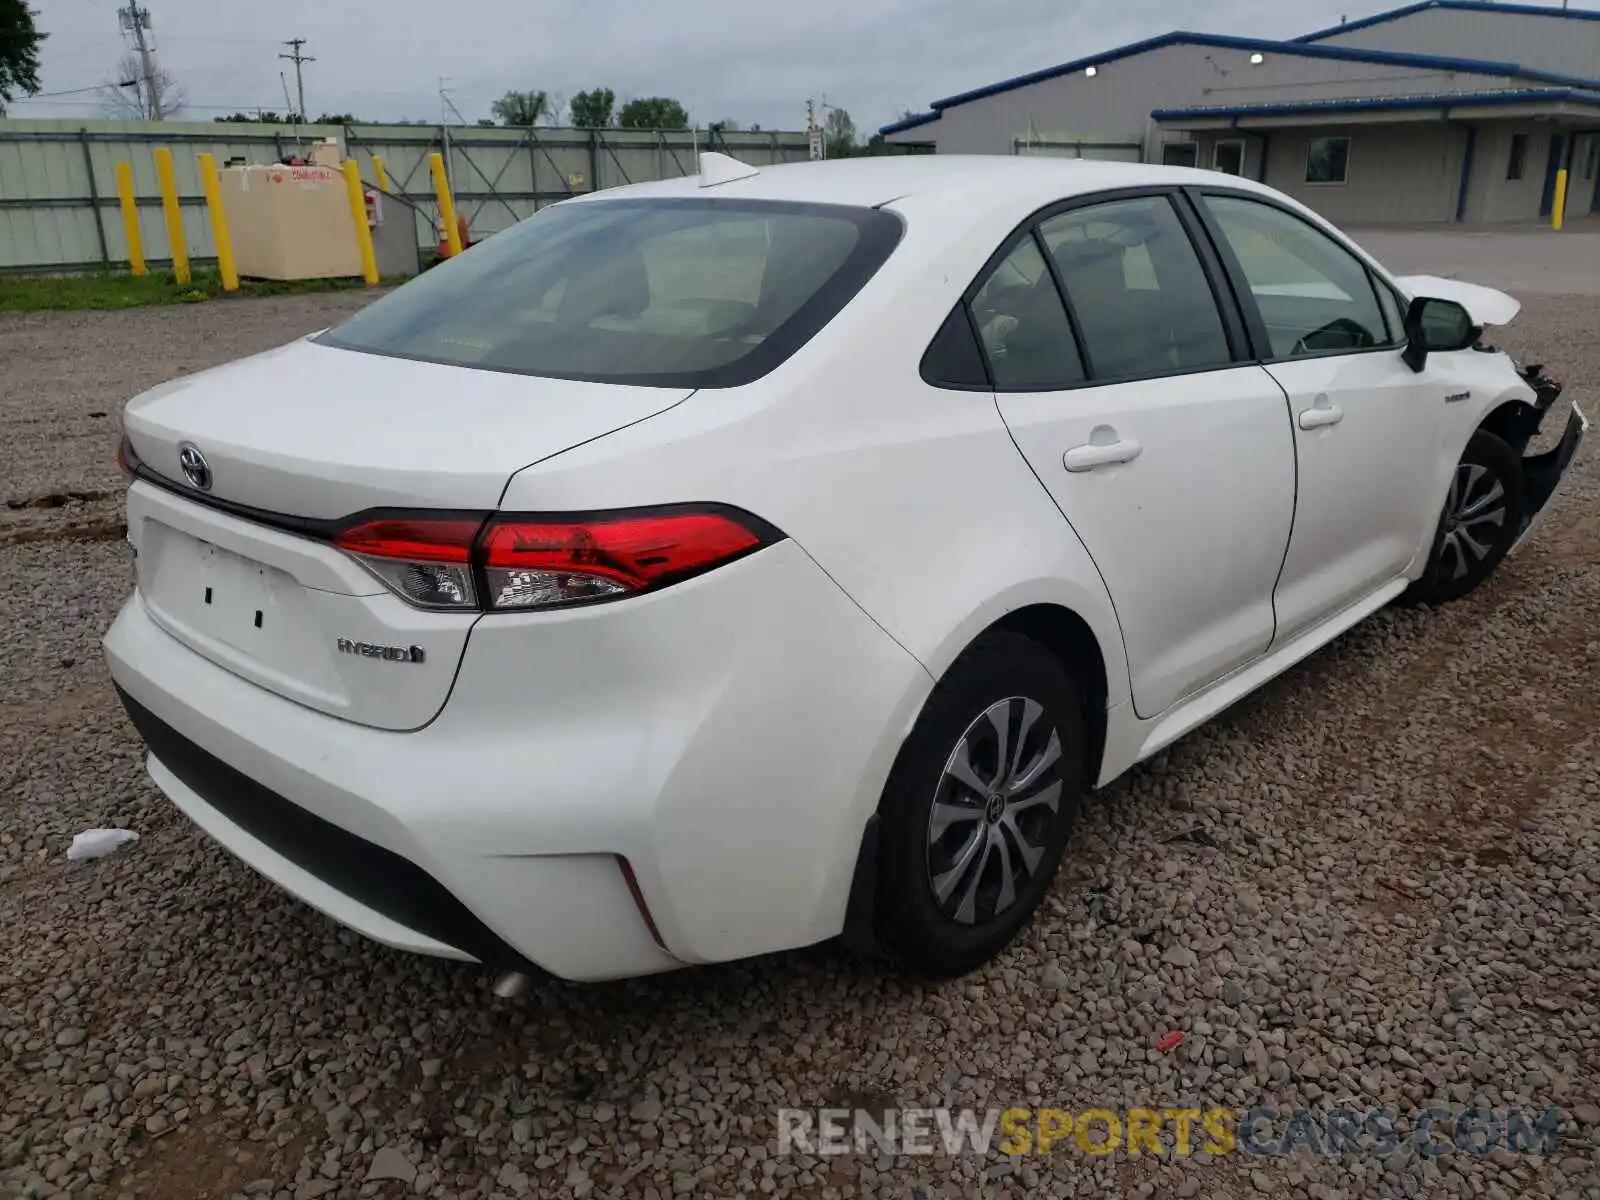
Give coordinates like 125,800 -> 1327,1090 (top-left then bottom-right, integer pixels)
502,197 -> 1128,706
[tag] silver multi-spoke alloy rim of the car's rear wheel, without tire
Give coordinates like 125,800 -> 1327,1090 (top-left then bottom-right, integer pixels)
926,696 -> 1064,925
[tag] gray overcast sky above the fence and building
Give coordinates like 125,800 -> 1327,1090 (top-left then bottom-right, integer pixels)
10,0 -> 1350,136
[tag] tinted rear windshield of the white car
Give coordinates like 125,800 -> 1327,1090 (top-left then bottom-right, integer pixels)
318,198 -> 901,387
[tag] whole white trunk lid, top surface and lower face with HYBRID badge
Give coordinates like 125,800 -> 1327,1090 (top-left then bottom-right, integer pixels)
123,342 -> 690,730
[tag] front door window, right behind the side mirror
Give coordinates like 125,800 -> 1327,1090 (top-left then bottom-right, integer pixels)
1205,195 -> 1390,358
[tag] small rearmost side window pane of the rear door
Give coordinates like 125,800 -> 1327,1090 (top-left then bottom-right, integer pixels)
971,235 -> 1083,390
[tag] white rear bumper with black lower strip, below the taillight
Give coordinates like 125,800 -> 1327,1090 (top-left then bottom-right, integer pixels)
106,542 -> 931,979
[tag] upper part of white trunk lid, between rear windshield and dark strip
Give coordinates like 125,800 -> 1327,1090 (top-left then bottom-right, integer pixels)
123,341 -> 690,518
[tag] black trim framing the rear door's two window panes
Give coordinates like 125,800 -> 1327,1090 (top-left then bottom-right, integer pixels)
925,184 -> 1258,395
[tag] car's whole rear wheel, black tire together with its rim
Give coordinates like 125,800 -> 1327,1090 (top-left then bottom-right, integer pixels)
874,632 -> 1083,978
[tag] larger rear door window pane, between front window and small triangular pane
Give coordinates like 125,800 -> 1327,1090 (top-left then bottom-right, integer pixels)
1038,195 -> 1232,381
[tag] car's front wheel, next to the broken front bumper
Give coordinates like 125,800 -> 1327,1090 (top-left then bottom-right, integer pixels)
1406,430 -> 1526,605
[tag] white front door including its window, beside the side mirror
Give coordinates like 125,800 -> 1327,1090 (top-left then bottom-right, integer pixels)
1203,194 -> 1443,642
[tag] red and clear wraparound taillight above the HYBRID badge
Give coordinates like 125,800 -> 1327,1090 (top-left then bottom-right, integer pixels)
334,509 -> 782,610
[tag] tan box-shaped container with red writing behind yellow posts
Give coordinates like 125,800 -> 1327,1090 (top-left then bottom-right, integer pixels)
222,165 -> 362,278
